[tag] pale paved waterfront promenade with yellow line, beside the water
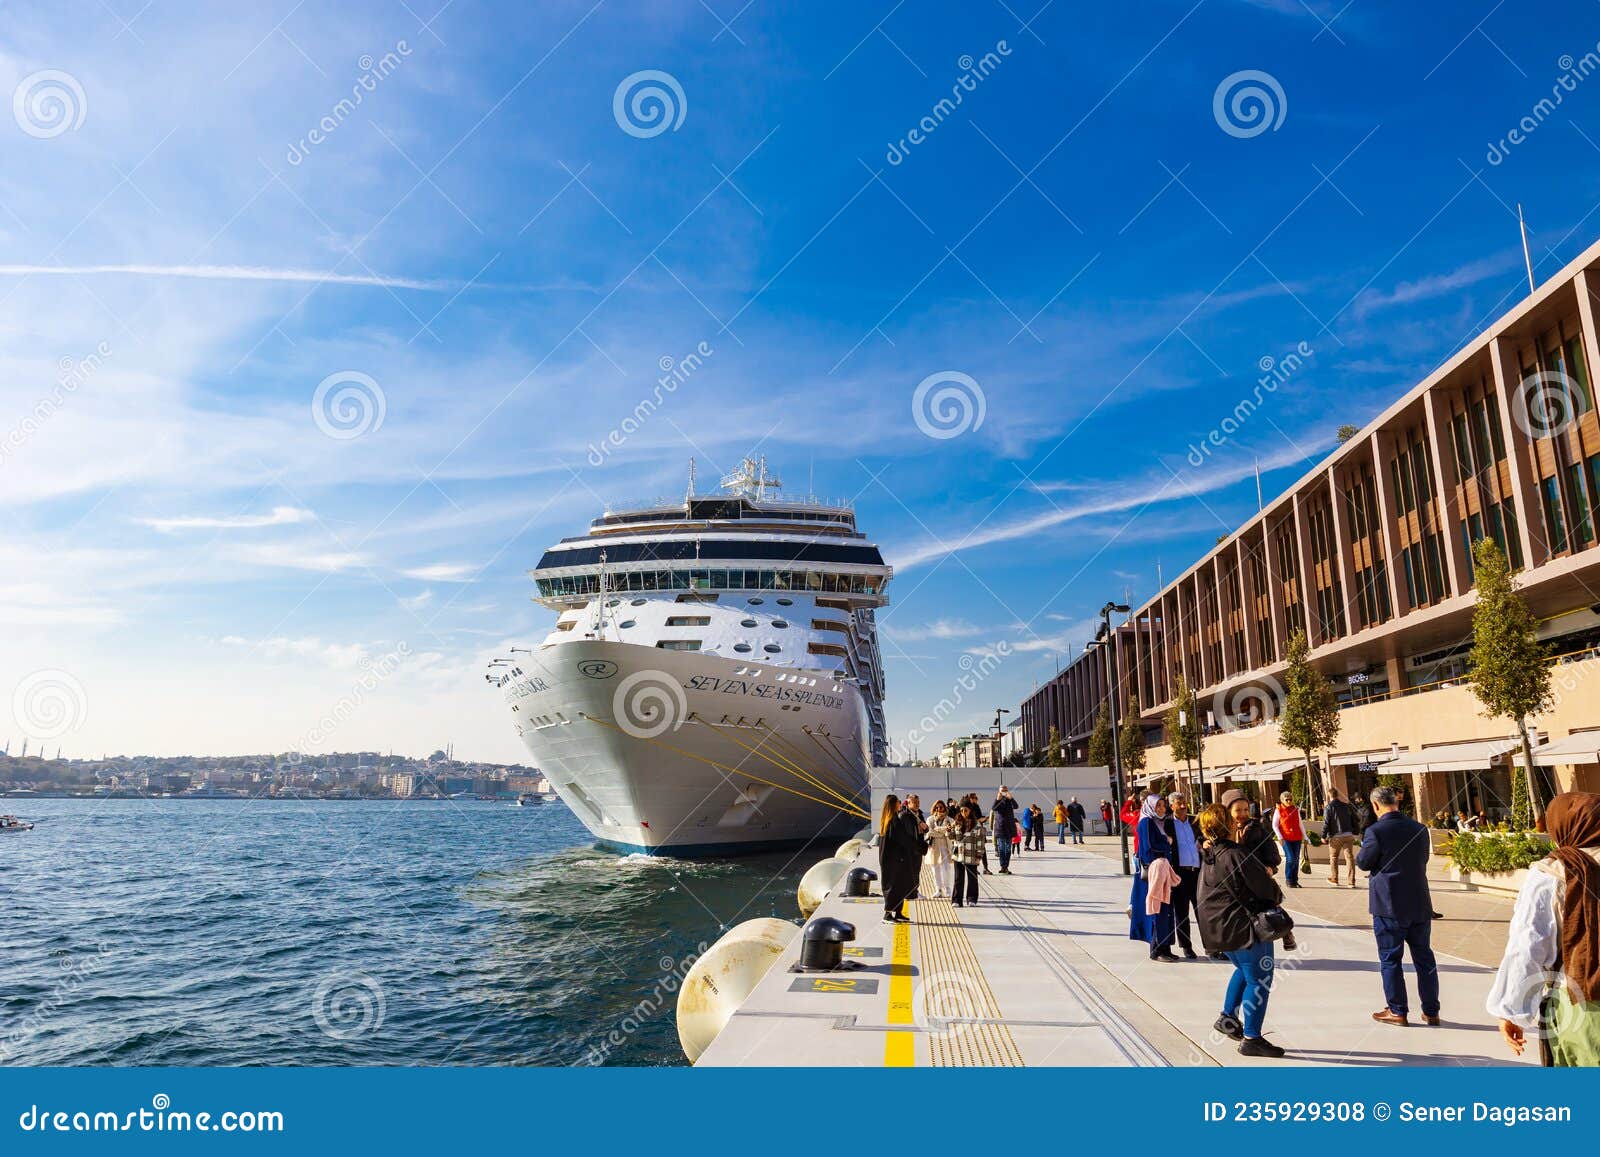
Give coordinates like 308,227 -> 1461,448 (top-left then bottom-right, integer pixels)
701,839 -> 1531,1067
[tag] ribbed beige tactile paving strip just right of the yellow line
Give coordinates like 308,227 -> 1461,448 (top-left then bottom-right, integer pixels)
915,866 -> 1022,1069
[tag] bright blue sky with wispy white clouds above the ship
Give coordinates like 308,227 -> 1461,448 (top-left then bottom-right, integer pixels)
0,0 -> 1600,760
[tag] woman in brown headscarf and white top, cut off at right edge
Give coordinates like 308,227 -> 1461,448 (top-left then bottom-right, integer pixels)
1488,792 -> 1600,1067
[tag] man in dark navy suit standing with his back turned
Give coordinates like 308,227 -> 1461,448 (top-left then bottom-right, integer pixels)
1355,787 -> 1440,1024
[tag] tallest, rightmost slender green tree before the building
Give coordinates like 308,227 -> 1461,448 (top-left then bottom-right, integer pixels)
1472,538 -> 1555,827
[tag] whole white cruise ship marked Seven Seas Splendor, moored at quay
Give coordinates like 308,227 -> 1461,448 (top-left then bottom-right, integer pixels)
488,458 -> 893,856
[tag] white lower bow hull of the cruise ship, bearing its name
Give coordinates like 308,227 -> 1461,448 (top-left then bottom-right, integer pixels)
502,640 -> 869,856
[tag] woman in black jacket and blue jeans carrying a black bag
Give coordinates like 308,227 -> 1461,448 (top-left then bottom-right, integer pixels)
1195,803 -> 1283,1059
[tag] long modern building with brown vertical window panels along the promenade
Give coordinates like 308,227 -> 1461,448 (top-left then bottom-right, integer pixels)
1021,233 -> 1600,818
